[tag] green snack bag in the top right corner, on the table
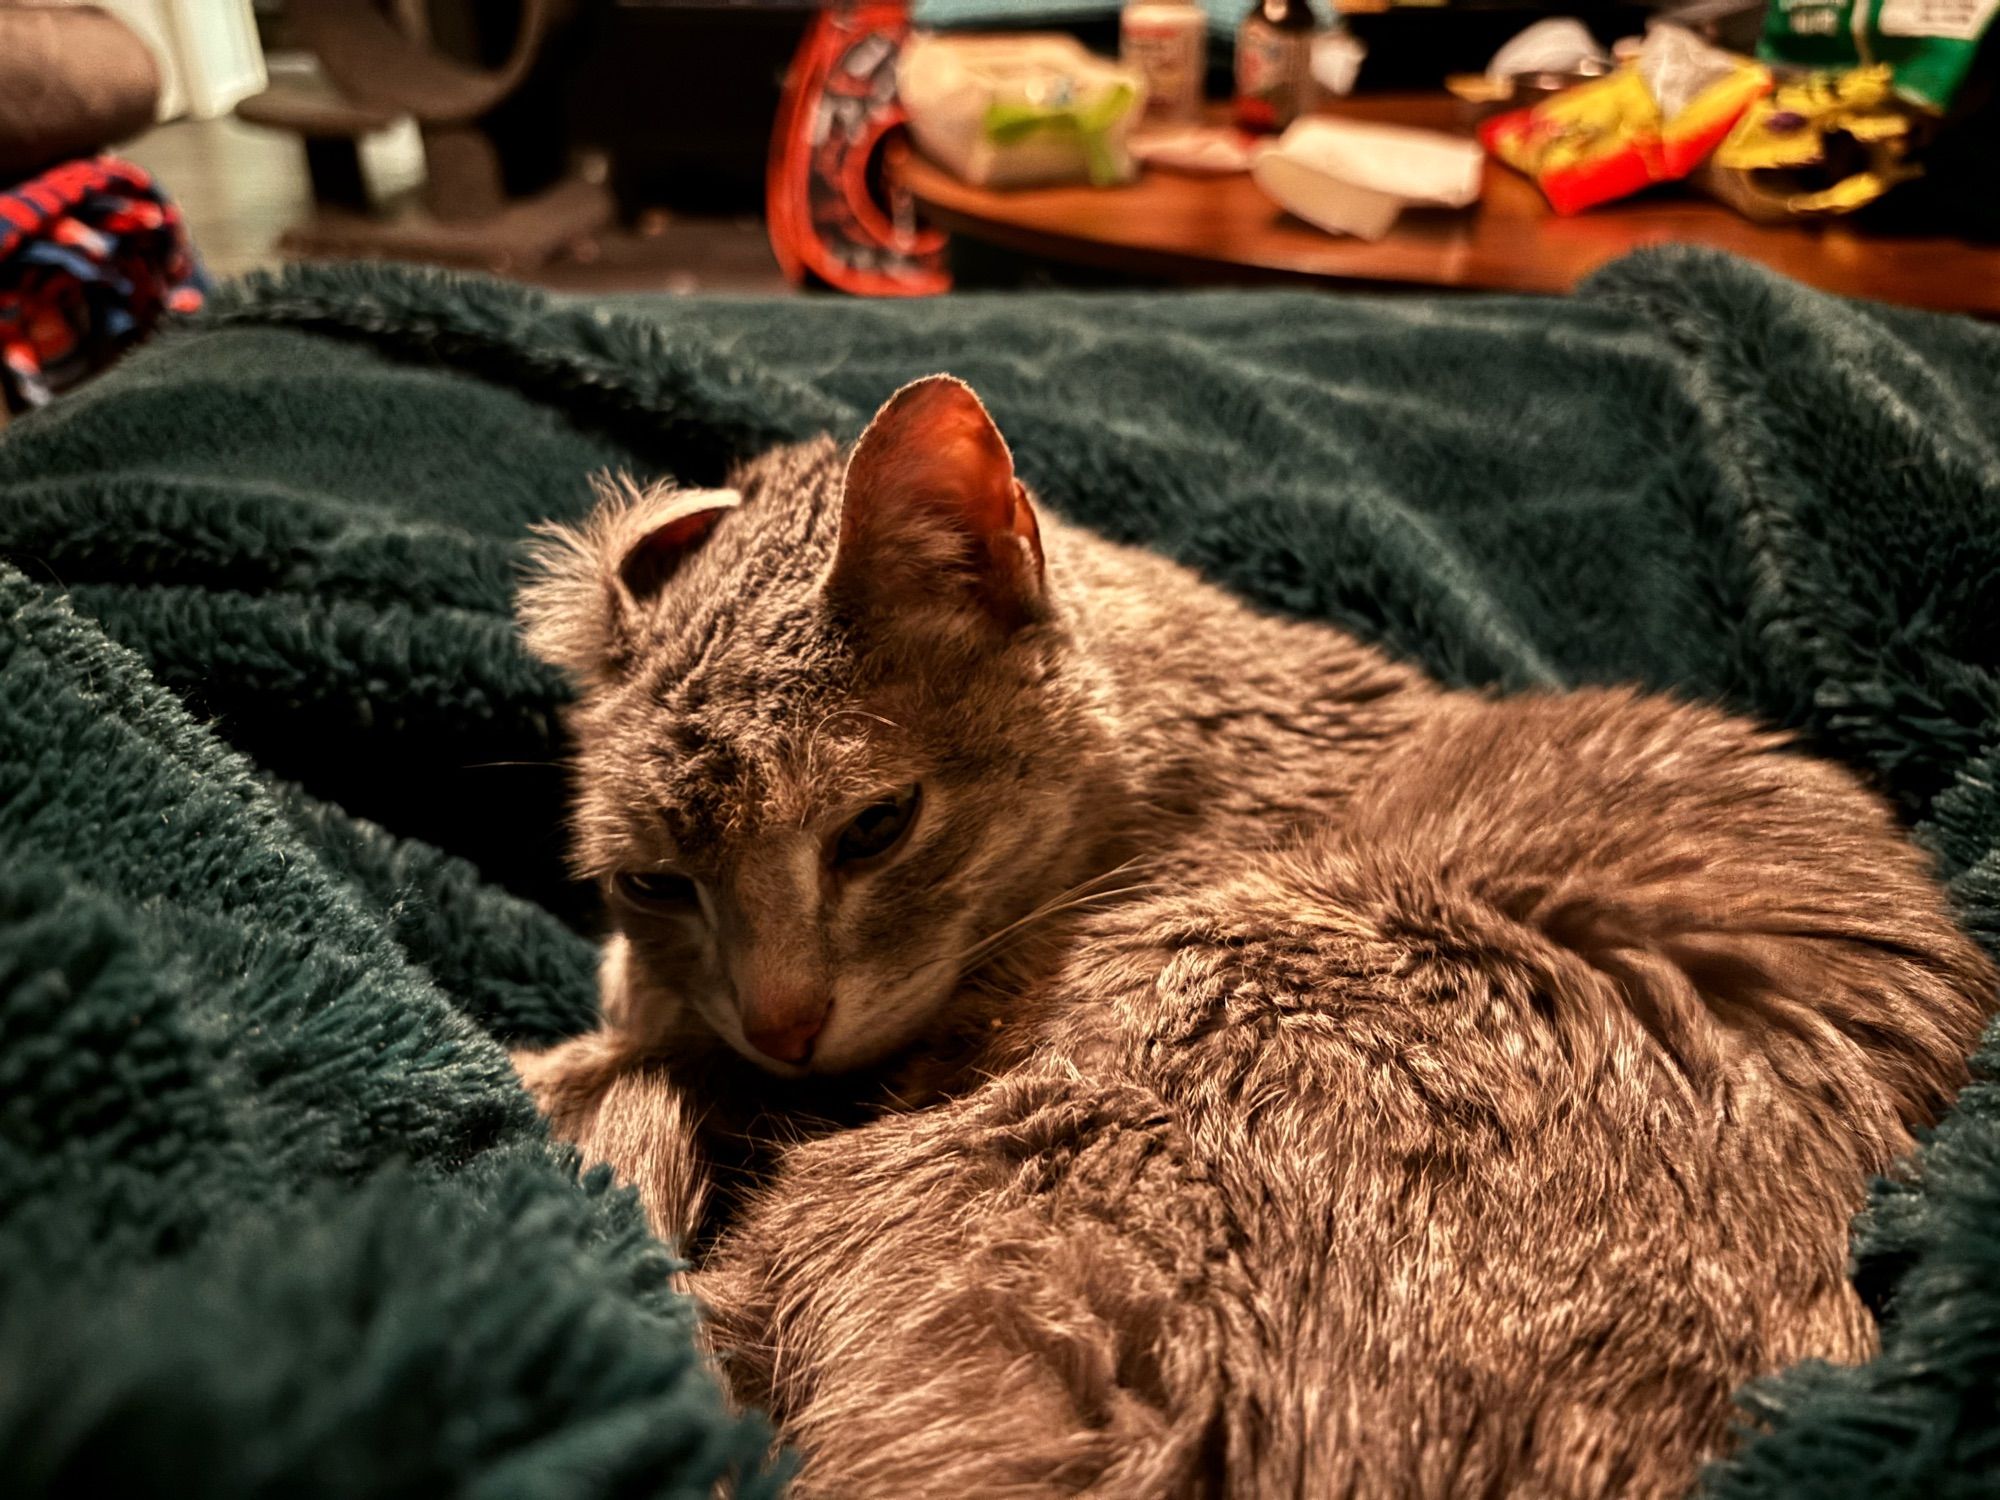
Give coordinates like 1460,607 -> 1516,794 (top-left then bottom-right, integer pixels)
1758,0 -> 2000,114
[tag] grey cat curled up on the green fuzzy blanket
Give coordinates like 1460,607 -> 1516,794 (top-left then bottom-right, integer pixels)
518,378 -> 1994,1500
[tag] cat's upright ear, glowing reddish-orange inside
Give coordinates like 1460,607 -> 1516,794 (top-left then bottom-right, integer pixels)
828,376 -> 1046,630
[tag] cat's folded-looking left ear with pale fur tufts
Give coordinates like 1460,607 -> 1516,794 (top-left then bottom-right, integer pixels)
516,474 -> 742,688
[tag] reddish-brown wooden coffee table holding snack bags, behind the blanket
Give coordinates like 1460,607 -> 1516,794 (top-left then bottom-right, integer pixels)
904,94 -> 2000,316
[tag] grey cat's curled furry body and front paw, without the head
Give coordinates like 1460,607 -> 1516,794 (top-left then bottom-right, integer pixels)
522,378 -> 1994,1500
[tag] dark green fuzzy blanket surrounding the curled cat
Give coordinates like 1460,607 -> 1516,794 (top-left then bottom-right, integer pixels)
0,252 -> 2000,1500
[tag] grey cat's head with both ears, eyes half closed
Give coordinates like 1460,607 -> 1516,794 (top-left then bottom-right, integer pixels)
520,376 -> 1116,1074
